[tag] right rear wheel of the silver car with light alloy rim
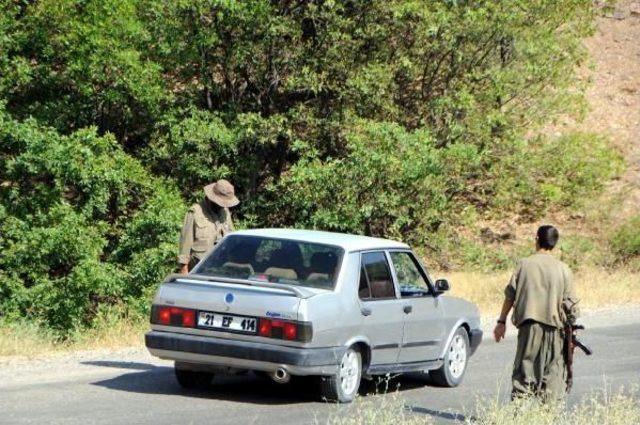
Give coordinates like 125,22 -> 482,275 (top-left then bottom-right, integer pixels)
320,347 -> 362,403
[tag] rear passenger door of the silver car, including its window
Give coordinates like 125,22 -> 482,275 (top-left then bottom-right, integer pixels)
358,251 -> 404,365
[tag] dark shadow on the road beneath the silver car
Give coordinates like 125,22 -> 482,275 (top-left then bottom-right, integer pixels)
82,361 -> 448,406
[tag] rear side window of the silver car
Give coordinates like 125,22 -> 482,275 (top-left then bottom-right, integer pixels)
358,252 -> 396,300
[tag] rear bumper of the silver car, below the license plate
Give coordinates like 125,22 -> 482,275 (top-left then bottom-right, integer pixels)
145,331 -> 344,375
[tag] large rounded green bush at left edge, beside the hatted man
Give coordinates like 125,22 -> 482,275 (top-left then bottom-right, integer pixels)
0,111 -> 183,336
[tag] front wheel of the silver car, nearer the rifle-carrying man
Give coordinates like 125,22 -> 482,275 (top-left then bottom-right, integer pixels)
429,327 -> 469,387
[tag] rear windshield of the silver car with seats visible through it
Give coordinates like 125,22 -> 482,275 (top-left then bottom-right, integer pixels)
195,235 -> 343,289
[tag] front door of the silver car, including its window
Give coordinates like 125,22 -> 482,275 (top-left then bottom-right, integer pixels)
389,251 -> 446,363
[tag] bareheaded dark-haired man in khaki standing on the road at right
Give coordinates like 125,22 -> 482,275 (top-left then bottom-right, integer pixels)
493,226 -> 578,400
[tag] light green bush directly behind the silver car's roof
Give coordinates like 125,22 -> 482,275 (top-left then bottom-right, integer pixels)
269,121 -> 448,239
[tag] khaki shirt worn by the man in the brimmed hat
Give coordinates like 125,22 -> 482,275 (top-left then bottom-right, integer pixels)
178,200 -> 233,264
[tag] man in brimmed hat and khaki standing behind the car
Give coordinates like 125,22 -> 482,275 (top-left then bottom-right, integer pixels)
178,180 -> 240,274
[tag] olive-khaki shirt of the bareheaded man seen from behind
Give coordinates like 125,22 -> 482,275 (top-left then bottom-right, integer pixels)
504,252 -> 578,328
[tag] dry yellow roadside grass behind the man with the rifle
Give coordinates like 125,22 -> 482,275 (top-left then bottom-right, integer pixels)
442,268 -> 640,315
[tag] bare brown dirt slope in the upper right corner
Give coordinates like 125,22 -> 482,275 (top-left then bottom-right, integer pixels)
481,4 -> 640,244
